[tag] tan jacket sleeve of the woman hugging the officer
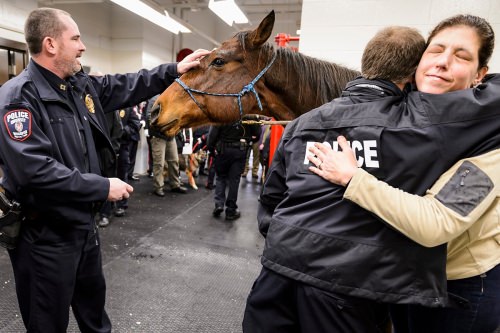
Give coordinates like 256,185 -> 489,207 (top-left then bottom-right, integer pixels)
344,150 -> 500,247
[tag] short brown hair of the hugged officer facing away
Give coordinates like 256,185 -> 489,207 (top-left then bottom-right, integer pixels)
361,26 -> 425,83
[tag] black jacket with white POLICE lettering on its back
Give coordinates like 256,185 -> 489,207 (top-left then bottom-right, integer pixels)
258,76 -> 500,307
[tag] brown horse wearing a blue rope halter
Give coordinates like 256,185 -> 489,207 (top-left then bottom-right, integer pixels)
152,11 -> 359,136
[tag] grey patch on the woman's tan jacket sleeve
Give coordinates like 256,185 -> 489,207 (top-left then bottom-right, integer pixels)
436,161 -> 494,216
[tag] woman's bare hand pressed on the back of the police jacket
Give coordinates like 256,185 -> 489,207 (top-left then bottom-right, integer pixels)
307,135 -> 358,186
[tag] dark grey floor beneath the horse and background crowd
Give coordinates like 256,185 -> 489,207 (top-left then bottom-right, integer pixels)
0,173 -> 264,333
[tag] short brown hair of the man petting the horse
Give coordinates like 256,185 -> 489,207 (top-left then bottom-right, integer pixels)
24,7 -> 71,55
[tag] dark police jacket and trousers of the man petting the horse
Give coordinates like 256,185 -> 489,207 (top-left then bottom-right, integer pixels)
0,60 -> 177,332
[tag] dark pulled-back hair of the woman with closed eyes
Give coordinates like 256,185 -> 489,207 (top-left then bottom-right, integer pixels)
427,14 -> 495,68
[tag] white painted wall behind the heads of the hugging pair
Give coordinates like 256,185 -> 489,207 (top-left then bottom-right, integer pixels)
299,0 -> 500,72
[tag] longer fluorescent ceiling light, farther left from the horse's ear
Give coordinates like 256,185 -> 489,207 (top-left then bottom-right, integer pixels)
111,0 -> 191,34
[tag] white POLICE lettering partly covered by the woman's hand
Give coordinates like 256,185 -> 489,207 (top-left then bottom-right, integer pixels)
304,140 -> 379,168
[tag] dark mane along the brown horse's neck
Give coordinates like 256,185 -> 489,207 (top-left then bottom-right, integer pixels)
235,31 -> 360,105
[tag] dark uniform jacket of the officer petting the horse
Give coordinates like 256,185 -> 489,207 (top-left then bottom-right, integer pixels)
0,61 -> 177,229
